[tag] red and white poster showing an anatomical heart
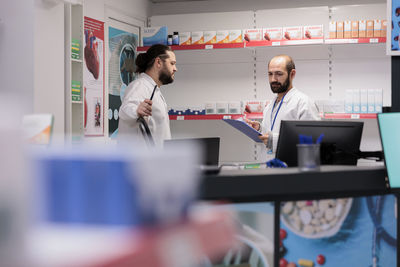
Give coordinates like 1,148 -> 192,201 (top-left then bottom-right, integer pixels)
83,17 -> 104,136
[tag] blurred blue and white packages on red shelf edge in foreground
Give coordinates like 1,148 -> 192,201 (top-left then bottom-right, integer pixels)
29,143 -> 235,267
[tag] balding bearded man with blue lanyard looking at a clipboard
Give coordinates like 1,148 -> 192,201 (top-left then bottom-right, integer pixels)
246,55 -> 320,152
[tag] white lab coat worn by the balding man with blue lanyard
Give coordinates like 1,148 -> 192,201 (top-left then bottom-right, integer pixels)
261,87 -> 321,152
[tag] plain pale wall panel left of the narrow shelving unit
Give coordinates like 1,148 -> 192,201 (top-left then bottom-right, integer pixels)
33,0 -> 65,136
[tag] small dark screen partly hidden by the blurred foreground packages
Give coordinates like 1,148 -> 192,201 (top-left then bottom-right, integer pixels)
164,137 -> 220,166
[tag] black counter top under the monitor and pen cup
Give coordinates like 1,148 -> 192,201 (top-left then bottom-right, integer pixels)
200,166 -> 390,202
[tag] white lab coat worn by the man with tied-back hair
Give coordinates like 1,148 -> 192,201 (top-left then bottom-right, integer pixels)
118,73 -> 171,146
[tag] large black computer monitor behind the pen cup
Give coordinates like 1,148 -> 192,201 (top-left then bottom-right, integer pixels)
276,121 -> 364,167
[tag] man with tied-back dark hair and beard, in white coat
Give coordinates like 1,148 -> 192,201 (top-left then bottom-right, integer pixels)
118,44 -> 177,146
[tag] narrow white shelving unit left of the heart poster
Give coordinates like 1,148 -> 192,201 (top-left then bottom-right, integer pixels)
64,3 -> 84,141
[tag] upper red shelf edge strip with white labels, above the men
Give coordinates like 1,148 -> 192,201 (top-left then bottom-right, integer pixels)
137,37 -> 386,52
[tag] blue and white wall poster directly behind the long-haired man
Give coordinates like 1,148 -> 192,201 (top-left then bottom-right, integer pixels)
108,20 -> 140,138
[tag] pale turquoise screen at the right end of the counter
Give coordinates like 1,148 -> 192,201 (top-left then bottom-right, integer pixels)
378,112 -> 400,189
